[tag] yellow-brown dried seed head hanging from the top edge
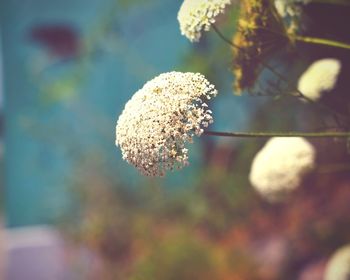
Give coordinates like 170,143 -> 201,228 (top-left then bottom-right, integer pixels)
232,0 -> 289,94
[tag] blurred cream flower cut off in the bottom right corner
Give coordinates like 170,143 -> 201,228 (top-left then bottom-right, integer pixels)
324,245 -> 350,280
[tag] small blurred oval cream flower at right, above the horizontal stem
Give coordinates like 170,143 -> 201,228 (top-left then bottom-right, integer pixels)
298,58 -> 341,101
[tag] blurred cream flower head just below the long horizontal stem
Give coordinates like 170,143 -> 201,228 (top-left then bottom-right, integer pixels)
249,137 -> 315,202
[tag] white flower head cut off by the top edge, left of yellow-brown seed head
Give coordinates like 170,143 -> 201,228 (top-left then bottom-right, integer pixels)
177,0 -> 231,42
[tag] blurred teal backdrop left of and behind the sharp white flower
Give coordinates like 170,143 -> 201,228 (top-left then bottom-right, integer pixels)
1,0 -> 249,227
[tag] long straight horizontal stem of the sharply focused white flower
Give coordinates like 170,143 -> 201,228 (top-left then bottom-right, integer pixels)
203,131 -> 350,138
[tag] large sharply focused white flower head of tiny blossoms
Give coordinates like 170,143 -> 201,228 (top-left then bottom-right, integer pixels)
116,72 -> 217,176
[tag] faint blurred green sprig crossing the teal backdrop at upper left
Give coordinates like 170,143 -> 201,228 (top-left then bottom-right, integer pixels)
32,0 -> 154,104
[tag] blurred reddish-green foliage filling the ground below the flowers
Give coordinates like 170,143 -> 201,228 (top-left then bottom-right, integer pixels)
63,135 -> 350,280
